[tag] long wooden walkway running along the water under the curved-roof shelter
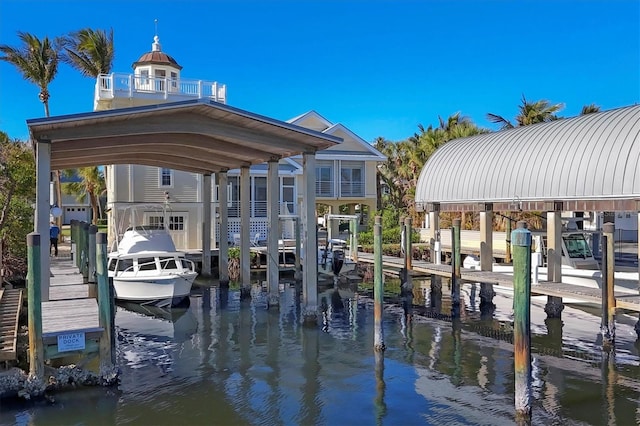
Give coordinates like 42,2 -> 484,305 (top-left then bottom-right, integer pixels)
358,252 -> 640,312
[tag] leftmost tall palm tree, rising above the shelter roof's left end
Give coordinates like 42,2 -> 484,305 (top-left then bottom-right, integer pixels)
0,31 -> 62,225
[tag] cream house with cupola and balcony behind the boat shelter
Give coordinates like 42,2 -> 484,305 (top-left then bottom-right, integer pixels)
94,36 -> 386,250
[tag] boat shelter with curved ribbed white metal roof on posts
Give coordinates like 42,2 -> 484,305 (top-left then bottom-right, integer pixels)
415,105 -> 640,282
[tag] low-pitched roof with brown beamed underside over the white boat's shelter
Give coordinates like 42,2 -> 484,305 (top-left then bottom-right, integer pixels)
27,99 -> 342,173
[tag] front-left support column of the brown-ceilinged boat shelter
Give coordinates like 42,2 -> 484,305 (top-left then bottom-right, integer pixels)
34,139 -> 51,302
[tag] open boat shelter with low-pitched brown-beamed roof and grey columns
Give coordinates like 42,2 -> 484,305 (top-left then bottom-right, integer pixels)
27,99 -> 342,316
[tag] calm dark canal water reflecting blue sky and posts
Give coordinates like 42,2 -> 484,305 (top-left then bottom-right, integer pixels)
0,281 -> 640,425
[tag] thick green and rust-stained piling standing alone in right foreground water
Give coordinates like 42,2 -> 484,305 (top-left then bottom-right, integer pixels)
511,221 -> 532,420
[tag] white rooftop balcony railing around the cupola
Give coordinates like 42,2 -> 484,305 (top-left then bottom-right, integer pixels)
96,73 -> 227,103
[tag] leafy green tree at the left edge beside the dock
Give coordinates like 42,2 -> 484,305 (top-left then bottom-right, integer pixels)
0,131 -> 35,281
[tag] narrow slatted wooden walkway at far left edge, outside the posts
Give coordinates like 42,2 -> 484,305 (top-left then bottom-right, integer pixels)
0,288 -> 23,361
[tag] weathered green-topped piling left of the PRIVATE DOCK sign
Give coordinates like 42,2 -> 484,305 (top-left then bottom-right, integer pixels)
27,232 -> 44,380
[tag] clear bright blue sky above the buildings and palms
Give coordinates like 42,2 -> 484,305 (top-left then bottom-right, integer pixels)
0,0 -> 640,142
